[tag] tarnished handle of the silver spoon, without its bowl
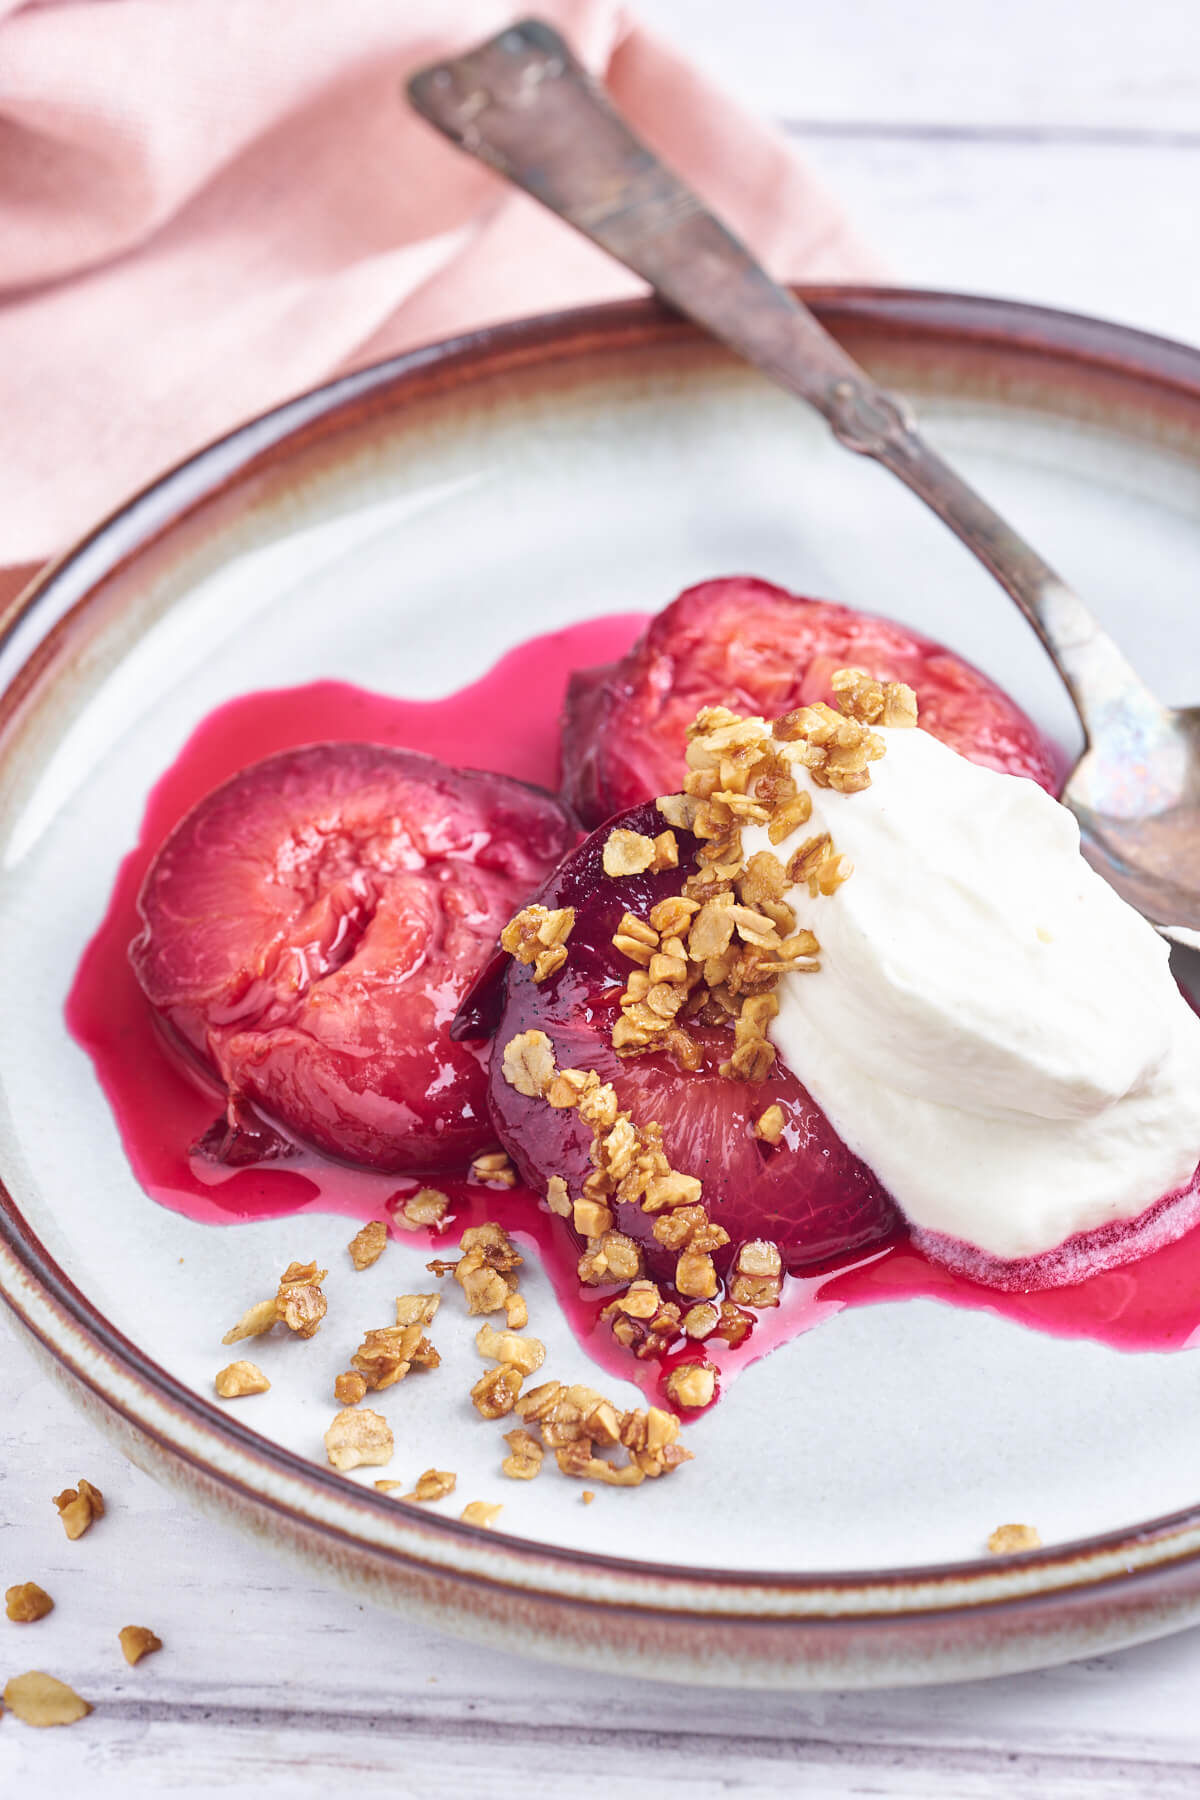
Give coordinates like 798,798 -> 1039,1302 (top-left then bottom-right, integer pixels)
408,20 -> 1137,731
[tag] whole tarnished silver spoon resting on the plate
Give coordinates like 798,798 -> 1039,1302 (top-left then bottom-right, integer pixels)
408,20 -> 1200,949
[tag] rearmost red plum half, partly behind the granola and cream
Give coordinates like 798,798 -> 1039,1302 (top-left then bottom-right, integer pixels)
563,576 -> 1061,824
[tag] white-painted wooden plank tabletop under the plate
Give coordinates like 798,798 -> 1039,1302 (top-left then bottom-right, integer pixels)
0,0 -> 1200,1800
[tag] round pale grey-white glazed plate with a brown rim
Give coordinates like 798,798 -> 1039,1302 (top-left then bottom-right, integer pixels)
0,293 -> 1200,1685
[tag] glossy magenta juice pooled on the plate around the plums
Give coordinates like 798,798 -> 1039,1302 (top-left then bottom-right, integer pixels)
67,614 -> 1200,1397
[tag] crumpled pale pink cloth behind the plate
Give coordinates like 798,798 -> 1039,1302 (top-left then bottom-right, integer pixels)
0,0 -> 874,586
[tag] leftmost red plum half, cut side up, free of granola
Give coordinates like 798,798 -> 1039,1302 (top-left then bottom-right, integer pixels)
130,743 -> 579,1170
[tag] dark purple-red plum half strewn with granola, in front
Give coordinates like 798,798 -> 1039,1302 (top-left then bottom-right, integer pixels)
467,805 -> 898,1280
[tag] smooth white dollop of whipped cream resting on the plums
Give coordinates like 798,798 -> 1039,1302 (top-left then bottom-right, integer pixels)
741,729 -> 1200,1260
